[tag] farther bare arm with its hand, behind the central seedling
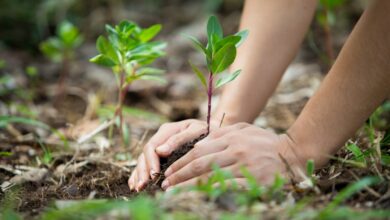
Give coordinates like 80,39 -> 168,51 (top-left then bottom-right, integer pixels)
129,0 -> 316,190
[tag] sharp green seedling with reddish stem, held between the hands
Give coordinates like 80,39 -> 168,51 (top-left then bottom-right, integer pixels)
188,16 -> 248,134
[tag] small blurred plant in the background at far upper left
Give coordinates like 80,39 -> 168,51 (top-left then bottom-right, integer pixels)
40,21 -> 83,95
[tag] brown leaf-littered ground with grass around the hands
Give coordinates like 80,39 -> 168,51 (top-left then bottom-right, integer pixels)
0,1 -> 390,219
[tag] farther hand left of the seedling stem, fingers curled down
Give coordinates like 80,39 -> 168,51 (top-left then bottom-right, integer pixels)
128,119 -> 213,191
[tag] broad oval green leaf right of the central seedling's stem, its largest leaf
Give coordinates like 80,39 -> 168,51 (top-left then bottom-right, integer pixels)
211,43 -> 237,74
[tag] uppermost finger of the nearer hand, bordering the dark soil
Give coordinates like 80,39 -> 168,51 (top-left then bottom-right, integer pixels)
164,139 -> 228,177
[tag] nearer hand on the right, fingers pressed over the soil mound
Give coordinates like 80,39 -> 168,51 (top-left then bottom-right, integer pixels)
162,123 -> 306,189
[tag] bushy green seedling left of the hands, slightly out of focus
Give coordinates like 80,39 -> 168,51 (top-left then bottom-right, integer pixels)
90,21 -> 166,148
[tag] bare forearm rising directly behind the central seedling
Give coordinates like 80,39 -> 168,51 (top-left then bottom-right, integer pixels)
213,0 -> 316,125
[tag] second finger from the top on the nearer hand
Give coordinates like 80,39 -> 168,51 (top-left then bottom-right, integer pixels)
161,151 -> 236,189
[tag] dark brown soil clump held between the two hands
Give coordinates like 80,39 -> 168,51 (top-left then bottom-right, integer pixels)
144,134 -> 207,193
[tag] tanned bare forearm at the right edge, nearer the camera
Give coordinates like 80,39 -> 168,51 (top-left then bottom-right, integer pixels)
288,1 -> 390,165
